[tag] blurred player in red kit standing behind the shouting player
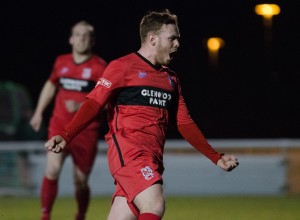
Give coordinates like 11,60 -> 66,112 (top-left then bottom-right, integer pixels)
30,21 -> 107,220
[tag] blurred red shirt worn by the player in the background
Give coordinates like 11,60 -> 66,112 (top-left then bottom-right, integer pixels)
50,54 -> 107,131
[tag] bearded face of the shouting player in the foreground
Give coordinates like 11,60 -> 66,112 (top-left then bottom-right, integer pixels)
156,24 -> 180,65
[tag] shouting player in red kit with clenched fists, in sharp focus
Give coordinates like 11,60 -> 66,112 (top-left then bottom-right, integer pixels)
45,10 -> 238,220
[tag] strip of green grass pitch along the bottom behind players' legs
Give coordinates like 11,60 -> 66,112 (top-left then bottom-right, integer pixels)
0,196 -> 300,220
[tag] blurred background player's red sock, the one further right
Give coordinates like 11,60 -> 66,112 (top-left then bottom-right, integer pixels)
75,187 -> 90,220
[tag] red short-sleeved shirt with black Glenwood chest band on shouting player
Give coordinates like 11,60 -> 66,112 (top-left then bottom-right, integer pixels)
87,53 -> 193,173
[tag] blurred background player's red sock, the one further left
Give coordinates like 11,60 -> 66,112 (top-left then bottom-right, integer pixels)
40,176 -> 58,220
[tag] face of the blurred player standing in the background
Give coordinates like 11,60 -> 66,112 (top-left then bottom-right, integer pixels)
70,25 -> 93,54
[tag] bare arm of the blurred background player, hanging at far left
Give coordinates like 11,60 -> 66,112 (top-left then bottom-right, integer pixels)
29,80 -> 57,132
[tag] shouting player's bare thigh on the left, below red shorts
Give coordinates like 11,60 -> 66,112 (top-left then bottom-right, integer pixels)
107,196 -> 137,220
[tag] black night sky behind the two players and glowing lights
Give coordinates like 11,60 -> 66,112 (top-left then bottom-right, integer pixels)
0,0 -> 300,138
